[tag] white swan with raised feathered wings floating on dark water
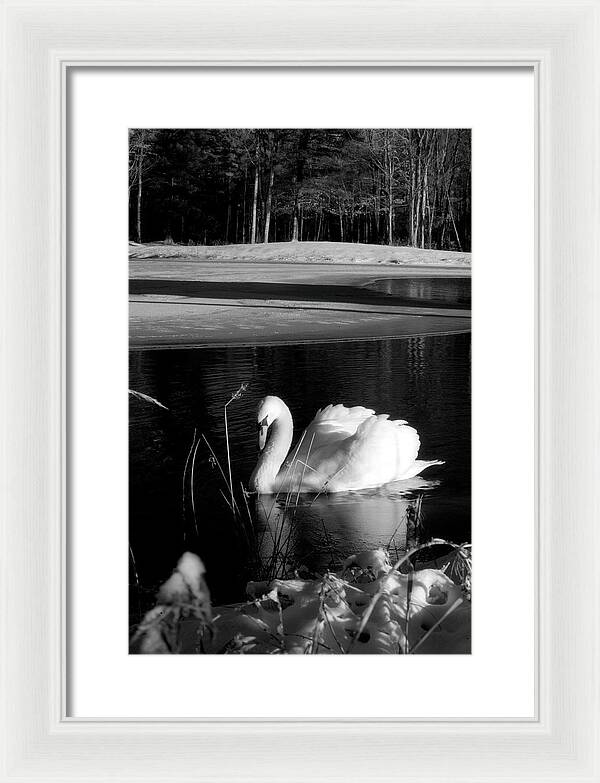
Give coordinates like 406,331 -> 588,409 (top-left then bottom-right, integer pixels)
250,395 -> 443,494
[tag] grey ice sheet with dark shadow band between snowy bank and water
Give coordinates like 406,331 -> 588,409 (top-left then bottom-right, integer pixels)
129,254 -> 471,350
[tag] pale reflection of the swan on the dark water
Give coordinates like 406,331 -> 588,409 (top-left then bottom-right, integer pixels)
253,476 -> 440,571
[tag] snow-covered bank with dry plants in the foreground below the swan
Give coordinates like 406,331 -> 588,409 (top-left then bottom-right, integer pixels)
132,542 -> 471,655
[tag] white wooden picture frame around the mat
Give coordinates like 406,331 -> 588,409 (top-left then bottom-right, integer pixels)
0,0 -> 600,782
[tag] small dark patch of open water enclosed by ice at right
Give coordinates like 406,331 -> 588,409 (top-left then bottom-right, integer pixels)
365,277 -> 471,309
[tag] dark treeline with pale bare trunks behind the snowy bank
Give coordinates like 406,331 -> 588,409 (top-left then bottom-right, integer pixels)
129,129 -> 471,251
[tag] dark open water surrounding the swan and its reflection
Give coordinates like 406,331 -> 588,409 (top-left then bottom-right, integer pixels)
130,334 -> 471,614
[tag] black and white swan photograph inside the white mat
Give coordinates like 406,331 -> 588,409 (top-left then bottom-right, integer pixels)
129,128 -> 477,655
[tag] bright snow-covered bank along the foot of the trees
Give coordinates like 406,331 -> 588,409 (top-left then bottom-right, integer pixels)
129,242 -> 471,268
